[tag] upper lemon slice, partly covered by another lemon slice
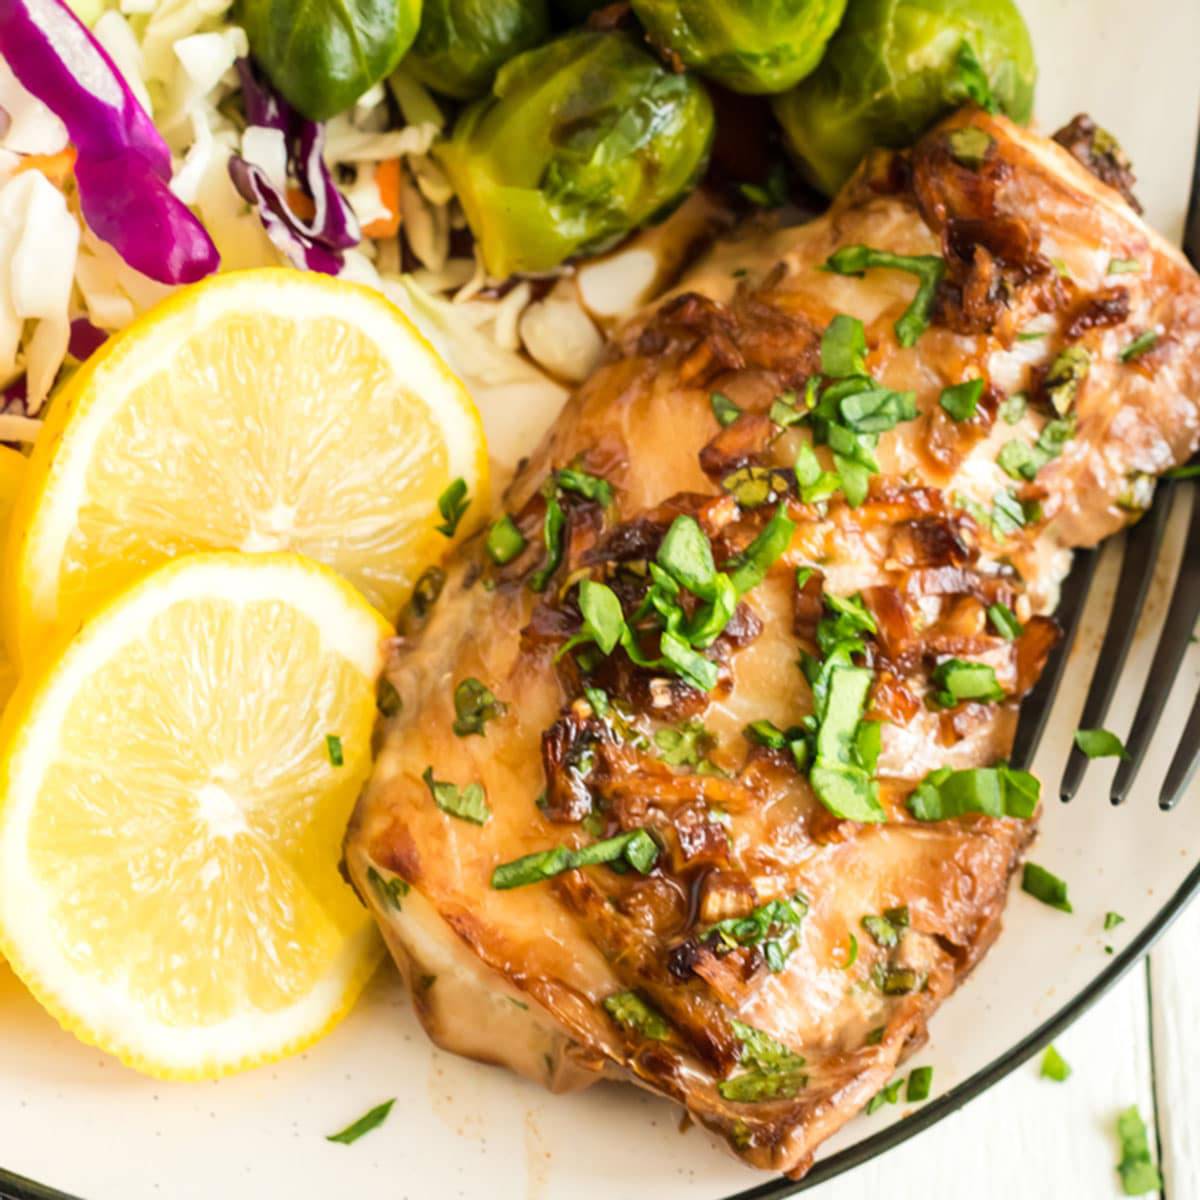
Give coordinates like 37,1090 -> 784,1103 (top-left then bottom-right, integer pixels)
2,269 -> 487,662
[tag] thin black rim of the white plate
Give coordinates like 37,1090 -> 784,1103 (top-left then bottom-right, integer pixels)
0,863 -> 1200,1200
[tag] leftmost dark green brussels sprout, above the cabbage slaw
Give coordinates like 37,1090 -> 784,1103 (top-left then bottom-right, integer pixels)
236,0 -> 421,121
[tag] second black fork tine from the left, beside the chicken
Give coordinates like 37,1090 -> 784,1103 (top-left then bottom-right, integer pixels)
1058,479 -> 1175,803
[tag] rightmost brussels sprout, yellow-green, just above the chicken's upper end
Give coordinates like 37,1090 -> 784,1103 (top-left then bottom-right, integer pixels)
774,0 -> 1037,193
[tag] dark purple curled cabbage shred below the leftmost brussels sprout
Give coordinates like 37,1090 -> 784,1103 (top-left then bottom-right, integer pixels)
228,62 -> 362,275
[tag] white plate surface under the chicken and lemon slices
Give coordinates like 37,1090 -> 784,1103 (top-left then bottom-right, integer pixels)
0,0 -> 1200,1200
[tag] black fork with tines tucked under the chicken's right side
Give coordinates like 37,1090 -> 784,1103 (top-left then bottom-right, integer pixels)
1012,112 -> 1200,809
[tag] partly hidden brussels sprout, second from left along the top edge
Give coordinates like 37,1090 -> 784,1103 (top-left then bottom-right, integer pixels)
404,0 -> 550,100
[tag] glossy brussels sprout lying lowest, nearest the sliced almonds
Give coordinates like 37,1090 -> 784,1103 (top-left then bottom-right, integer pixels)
436,32 -> 714,278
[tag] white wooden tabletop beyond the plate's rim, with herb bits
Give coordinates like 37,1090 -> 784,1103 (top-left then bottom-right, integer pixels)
812,901 -> 1200,1200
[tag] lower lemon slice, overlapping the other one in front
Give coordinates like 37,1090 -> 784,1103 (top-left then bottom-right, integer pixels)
0,553 -> 389,1079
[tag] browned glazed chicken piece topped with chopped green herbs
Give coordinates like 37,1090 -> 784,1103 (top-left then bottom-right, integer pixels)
346,110 -> 1200,1176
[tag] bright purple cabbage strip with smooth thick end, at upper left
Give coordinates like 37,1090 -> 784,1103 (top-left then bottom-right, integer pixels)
0,0 -> 220,283
